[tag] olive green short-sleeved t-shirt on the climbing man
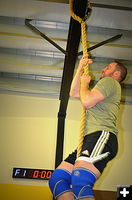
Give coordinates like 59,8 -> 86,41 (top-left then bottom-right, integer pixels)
85,77 -> 121,135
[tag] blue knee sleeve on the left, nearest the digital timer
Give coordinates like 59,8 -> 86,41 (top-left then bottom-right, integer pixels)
49,169 -> 71,198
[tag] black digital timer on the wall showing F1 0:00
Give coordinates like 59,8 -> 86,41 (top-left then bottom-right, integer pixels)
12,168 -> 53,180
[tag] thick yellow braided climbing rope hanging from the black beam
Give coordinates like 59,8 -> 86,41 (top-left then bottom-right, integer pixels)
69,0 -> 91,158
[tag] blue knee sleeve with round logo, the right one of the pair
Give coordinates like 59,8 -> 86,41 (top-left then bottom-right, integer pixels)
71,168 -> 97,199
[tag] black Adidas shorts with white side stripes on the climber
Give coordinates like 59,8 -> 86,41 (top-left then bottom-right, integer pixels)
64,131 -> 118,173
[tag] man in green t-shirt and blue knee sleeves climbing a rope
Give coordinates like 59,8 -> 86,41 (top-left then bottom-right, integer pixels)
49,55 -> 127,200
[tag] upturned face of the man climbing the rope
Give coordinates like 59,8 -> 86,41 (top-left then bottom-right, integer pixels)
100,62 -> 116,78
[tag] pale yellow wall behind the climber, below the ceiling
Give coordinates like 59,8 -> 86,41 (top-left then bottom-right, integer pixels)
0,94 -> 132,190
